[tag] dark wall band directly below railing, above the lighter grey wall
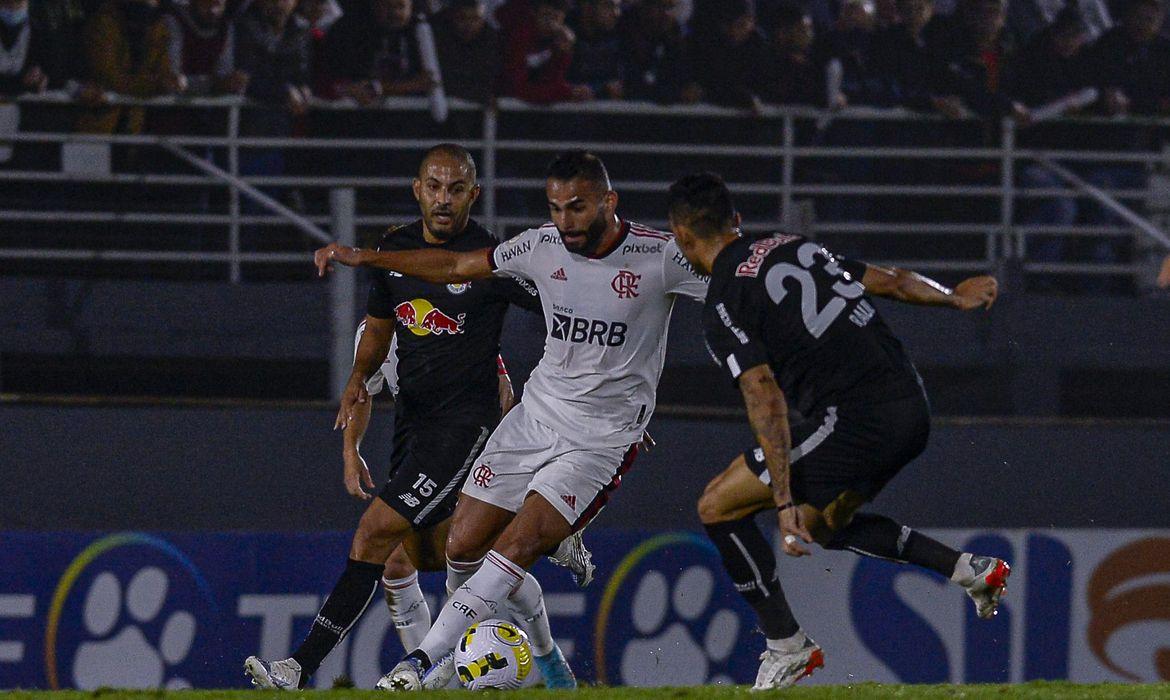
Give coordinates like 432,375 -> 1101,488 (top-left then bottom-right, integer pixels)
0,276 -> 1170,416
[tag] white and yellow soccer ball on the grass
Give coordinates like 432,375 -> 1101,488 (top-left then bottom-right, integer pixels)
455,619 -> 532,691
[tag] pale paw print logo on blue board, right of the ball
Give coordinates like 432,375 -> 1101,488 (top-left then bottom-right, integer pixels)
621,564 -> 742,686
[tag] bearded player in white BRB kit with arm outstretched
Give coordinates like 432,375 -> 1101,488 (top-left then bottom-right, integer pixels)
315,151 -> 707,691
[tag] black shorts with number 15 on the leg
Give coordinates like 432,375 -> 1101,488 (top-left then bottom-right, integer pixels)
378,421 -> 491,529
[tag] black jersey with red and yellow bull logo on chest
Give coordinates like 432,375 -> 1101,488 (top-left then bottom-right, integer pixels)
367,221 -> 541,425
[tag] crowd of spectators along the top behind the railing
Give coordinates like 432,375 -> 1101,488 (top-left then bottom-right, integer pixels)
0,0 -> 1170,125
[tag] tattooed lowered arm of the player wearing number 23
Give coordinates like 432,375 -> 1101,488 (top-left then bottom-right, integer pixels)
739,364 -> 812,556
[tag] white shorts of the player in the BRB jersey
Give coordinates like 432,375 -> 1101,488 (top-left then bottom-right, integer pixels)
463,402 -> 638,531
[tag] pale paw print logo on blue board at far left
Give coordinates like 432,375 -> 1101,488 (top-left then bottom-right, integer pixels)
73,567 -> 195,689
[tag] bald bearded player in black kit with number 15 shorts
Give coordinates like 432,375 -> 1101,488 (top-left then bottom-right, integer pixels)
245,144 -> 572,689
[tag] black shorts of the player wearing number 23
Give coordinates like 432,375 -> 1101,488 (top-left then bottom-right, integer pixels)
743,394 -> 930,510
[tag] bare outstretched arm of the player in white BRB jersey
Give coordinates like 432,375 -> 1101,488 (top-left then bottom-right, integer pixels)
312,242 -> 491,283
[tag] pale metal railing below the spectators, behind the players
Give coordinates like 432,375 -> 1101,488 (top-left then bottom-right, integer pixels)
0,92 -> 1170,282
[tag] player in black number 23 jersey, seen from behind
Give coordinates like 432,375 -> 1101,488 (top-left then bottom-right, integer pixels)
669,173 -> 1011,689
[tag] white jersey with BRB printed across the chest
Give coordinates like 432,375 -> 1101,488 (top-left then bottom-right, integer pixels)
491,221 -> 707,447
